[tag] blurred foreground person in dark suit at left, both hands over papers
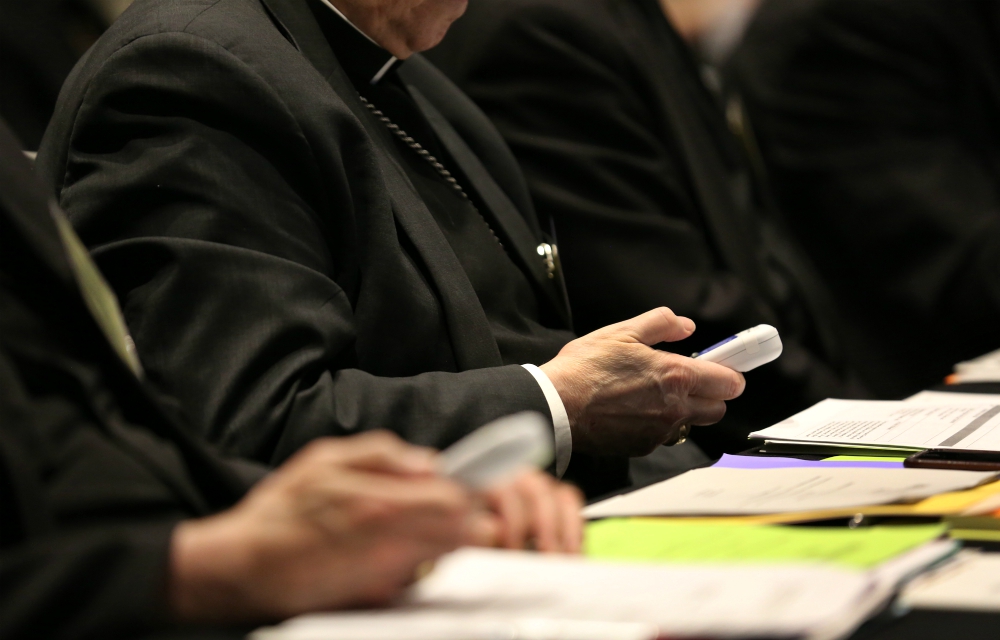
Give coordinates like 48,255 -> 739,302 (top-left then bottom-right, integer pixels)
0,116 -> 581,640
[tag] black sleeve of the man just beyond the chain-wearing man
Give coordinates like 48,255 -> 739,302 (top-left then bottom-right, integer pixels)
429,3 -> 753,339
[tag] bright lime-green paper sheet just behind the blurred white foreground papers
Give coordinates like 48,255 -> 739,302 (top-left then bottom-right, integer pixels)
584,518 -> 946,569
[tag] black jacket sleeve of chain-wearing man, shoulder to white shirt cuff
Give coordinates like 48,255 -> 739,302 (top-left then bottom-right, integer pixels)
40,33 -> 547,463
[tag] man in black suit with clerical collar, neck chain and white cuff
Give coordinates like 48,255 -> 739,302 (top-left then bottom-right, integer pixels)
39,0 -> 744,494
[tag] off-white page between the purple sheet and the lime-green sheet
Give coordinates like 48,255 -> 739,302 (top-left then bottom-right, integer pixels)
583,467 -> 996,519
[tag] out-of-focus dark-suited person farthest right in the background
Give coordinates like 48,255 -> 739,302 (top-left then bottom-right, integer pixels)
733,0 -> 1000,397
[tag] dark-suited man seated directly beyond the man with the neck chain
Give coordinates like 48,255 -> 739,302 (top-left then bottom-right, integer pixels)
428,0 -> 861,454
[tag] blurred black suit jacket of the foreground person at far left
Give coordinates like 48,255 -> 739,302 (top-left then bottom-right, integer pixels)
0,123 -> 263,640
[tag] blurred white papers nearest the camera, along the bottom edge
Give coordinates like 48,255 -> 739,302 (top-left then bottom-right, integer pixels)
252,543 -> 953,640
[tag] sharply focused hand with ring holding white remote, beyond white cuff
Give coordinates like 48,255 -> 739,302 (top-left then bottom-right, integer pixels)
540,307 -> 746,456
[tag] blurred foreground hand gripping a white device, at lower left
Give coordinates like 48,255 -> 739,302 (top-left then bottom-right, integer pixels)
168,433 -> 492,622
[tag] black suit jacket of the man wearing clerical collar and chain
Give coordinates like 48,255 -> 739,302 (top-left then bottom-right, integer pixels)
39,0 -> 620,484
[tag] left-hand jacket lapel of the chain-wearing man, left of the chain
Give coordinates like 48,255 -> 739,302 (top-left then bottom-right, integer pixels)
261,0 -> 503,371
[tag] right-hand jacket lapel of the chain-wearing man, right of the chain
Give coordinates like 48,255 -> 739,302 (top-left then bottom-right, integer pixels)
401,71 -> 570,326
